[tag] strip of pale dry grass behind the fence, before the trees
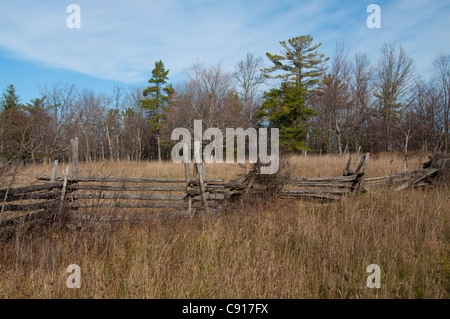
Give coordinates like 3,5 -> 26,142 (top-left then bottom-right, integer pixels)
15,153 -> 427,186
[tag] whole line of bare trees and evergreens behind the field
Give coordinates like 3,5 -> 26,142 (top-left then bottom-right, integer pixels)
0,35 -> 450,163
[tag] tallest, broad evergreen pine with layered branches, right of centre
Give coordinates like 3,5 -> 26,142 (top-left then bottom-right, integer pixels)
257,35 -> 328,151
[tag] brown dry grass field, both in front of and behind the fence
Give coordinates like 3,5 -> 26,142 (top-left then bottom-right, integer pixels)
0,154 -> 450,298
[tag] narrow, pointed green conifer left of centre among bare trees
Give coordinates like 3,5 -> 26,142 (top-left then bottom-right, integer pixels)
141,61 -> 173,162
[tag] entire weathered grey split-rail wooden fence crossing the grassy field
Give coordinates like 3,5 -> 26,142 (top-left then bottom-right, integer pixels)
0,139 -> 438,231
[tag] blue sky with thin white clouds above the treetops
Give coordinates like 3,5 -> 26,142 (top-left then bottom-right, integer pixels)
0,0 -> 450,102
